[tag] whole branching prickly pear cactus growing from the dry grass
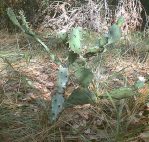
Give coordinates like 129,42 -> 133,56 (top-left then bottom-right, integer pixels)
7,8 -> 134,123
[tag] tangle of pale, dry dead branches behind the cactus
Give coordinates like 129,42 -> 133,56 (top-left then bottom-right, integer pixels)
37,0 -> 144,33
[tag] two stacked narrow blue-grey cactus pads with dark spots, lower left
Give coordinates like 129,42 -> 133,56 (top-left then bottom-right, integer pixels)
50,67 -> 68,123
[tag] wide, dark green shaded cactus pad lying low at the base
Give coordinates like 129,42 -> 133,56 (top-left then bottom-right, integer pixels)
64,88 -> 97,108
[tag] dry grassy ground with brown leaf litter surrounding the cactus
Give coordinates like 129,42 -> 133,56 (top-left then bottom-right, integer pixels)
0,31 -> 149,142
